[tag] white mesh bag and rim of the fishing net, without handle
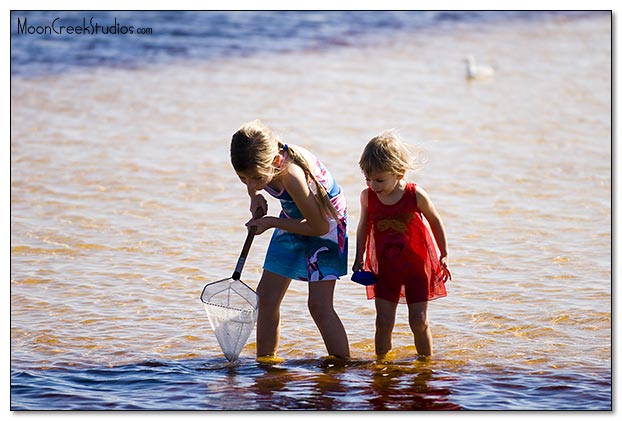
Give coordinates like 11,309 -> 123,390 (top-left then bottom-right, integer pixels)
201,279 -> 258,362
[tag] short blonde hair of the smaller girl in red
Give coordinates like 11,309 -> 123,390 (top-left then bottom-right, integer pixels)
359,129 -> 417,176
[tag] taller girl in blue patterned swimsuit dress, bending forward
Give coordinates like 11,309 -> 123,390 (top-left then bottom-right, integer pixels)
231,120 -> 350,358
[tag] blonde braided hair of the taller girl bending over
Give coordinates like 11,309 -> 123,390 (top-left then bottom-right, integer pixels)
230,120 -> 339,220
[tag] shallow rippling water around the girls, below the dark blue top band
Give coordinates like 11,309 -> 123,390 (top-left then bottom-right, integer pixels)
11,14 -> 612,410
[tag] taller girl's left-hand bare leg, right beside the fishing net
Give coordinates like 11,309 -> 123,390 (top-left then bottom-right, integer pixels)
257,271 -> 291,357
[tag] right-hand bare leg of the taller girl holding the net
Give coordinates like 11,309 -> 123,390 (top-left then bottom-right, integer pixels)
307,281 -> 350,358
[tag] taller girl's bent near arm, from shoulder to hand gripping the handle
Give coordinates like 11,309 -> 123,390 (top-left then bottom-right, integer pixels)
247,164 -> 330,237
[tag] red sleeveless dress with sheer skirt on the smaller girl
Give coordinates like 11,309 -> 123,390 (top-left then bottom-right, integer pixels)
365,183 -> 447,304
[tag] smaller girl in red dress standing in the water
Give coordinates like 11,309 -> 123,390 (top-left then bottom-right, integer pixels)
352,130 -> 451,356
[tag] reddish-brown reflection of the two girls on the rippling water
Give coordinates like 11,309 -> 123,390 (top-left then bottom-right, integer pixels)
250,359 -> 462,410
